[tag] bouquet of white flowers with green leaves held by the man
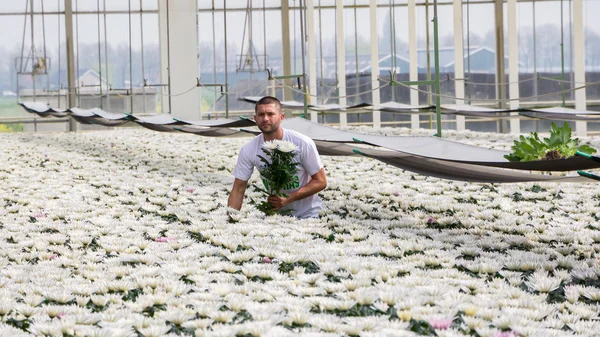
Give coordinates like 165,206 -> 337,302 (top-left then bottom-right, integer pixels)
257,140 -> 298,215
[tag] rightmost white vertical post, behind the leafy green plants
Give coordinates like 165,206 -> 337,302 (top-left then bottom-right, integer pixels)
572,0 -> 587,137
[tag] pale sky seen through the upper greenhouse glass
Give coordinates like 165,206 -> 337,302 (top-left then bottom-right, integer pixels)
0,0 -> 600,54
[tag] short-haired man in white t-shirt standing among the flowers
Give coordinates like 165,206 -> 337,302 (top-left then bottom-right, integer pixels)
227,96 -> 327,218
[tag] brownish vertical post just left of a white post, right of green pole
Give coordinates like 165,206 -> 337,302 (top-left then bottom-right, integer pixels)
494,0 -> 506,133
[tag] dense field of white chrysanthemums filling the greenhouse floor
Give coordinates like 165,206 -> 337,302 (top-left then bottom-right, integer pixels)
0,128 -> 600,337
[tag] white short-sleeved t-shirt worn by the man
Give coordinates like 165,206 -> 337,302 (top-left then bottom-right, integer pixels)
233,126 -> 323,218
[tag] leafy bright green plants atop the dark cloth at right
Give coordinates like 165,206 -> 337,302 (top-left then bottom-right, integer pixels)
504,122 -> 596,161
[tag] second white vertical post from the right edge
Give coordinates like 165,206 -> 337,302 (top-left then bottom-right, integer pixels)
507,0 -> 521,134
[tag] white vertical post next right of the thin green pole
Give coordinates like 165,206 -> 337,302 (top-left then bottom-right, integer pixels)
453,0 -> 465,131
